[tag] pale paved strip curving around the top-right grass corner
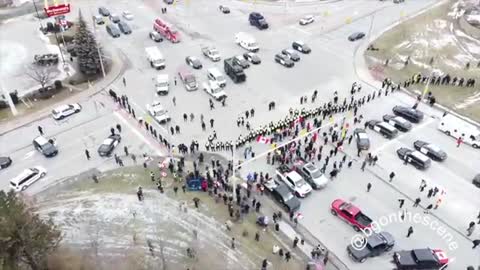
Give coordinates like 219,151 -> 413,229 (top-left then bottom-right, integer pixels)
353,0 -> 480,127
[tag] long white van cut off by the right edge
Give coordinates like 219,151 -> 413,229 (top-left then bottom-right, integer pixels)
438,114 -> 480,148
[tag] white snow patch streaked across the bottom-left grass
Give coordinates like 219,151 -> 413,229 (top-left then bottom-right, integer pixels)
37,190 -> 255,270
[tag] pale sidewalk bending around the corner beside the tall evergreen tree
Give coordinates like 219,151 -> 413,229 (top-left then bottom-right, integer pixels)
0,46 -> 125,136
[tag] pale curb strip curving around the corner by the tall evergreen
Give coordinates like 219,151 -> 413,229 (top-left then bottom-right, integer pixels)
0,47 -> 125,136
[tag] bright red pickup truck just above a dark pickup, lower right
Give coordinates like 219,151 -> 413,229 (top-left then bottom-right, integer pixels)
330,199 -> 372,232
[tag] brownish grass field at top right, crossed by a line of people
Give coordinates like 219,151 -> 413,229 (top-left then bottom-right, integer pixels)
364,0 -> 480,121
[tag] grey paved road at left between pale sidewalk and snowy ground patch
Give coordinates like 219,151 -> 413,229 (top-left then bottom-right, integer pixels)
0,94 -> 166,194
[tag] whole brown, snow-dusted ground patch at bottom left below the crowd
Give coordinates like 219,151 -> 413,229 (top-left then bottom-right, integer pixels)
35,167 -> 305,270
